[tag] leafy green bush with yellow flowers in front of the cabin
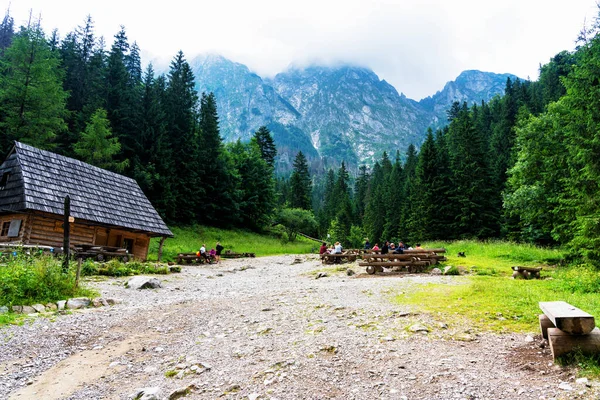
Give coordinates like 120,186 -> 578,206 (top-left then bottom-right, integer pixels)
0,254 -> 92,305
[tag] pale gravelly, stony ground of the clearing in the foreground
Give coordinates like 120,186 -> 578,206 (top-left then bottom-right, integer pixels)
0,255 -> 600,400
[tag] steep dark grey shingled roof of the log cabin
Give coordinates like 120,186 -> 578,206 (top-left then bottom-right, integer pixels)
0,142 -> 173,236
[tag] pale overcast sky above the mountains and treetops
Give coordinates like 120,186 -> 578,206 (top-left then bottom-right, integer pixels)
0,0 -> 598,100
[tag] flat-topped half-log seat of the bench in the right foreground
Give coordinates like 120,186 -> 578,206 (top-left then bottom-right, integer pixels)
540,301 -> 596,335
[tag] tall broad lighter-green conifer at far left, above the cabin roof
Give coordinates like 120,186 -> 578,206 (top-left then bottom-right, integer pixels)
0,23 -> 68,153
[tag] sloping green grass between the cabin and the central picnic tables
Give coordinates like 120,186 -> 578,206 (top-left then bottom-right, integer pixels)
148,225 -> 319,261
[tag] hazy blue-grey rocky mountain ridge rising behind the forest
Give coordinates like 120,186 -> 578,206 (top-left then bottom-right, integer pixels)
190,54 -> 517,172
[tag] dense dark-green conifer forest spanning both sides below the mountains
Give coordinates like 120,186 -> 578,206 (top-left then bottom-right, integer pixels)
0,9 -> 600,265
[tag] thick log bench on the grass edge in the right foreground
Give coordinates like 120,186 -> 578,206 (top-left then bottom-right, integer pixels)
539,301 -> 600,360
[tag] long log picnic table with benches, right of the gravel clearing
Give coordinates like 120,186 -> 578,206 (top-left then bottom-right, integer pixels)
358,249 -> 446,275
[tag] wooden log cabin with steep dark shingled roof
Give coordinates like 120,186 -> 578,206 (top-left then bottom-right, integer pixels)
0,142 -> 173,260
